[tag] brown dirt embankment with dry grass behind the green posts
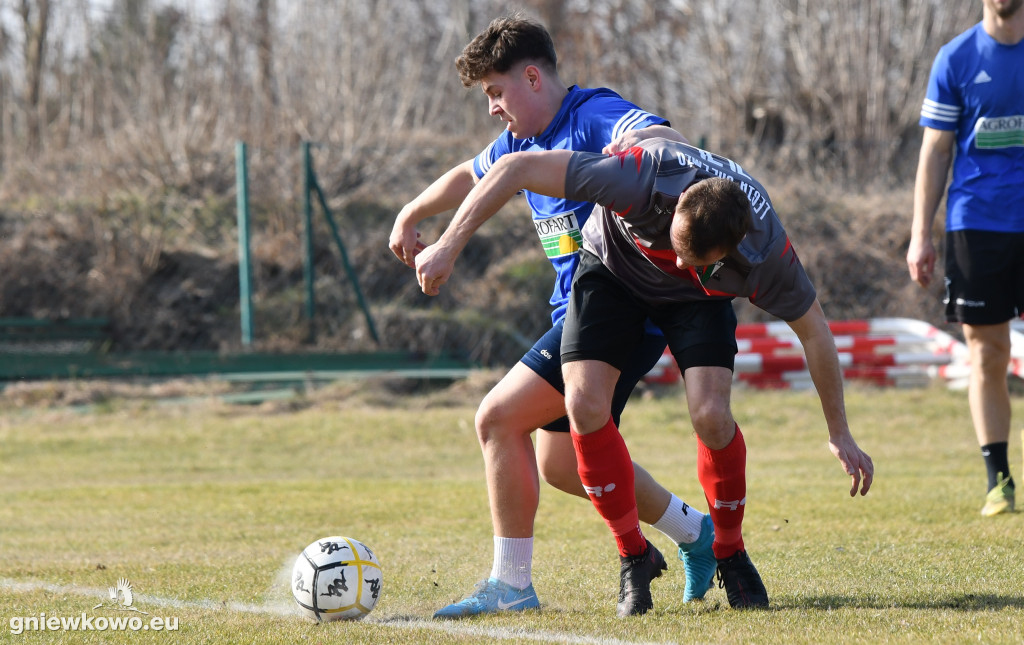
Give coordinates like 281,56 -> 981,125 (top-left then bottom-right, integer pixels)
0,183 -> 954,364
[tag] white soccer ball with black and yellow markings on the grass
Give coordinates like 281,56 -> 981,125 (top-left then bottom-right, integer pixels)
292,536 -> 383,622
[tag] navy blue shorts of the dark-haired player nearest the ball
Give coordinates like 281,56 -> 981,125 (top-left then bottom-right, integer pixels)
520,318 -> 665,432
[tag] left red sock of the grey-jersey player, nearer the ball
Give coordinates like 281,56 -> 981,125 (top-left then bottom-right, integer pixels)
569,419 -> 647,556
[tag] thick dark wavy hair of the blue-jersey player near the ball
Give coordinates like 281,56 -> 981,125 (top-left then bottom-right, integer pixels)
455,12 -> 558,87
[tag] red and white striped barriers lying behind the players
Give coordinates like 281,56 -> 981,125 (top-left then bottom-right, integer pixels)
644,318 -> 983,389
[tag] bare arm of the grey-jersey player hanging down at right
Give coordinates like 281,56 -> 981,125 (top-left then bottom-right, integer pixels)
790,300 -> 874,497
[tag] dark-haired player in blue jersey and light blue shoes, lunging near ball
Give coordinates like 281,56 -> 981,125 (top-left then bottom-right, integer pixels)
389,15 -> 716,618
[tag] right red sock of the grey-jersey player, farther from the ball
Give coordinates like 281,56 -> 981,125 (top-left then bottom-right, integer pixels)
697,425 -> 746,558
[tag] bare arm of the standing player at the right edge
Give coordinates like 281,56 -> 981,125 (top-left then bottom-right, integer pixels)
906,128 -> 956,287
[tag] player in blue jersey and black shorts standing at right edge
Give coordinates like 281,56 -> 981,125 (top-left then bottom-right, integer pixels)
906,0 -> 1024,517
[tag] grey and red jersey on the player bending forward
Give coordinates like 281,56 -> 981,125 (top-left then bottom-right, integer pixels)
565,139 -> 816,321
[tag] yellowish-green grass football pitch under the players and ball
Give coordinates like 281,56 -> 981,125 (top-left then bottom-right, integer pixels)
0,376 -> 1024,644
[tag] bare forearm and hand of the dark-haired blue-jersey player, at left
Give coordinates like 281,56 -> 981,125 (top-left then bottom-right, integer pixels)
388,159 -> 476,268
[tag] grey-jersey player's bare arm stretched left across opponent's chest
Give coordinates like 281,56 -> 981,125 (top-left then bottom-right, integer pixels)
416,151 -> 572,296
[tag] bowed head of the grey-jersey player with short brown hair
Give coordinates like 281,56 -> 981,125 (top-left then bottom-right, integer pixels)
671,177 -> 751,258
